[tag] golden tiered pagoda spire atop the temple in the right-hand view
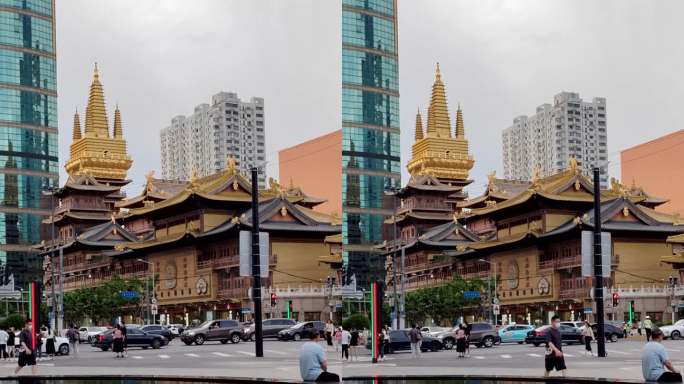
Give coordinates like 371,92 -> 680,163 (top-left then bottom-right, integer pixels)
407,64 -> 474,181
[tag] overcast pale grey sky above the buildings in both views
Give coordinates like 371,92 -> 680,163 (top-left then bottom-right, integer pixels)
57,0 -> 684,192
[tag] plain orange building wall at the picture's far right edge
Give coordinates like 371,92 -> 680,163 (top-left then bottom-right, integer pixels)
620,129 -> 684,216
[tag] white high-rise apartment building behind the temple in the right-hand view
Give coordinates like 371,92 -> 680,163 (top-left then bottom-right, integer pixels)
501,92 -> 608,187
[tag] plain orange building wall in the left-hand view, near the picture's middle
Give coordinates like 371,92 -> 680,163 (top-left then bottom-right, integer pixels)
278,130 -> 342,216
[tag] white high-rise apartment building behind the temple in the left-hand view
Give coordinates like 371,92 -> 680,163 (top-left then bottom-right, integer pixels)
160,92 -> 266,188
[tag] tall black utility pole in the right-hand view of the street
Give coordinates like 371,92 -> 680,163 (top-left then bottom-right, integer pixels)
594,167 -> 606,357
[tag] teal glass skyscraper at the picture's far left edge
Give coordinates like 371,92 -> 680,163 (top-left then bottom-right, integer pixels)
0,0 -> 59,287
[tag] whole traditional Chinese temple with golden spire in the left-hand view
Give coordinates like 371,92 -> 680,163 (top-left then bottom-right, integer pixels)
40,63 -> 341,323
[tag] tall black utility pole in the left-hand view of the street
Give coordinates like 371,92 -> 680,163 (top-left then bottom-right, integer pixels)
252,167 -> 264,357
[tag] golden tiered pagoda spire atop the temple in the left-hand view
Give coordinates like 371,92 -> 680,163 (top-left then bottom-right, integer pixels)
64,65 -> 133,181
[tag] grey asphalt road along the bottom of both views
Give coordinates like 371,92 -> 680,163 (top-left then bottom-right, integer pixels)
0,340 -> 684,380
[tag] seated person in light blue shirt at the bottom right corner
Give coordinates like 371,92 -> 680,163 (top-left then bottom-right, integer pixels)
641,329 -> 682,383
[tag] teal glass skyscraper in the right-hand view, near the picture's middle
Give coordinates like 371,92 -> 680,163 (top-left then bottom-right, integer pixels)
342,0 -> 401,290
